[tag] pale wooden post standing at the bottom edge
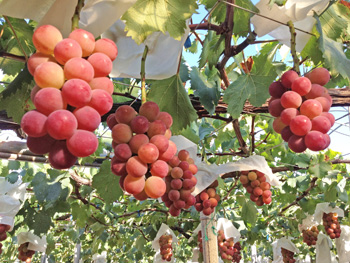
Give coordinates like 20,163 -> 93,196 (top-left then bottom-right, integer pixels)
200,212 -> 219,263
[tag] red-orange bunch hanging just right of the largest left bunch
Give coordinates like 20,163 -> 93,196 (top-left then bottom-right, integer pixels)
107,101 -> 177,200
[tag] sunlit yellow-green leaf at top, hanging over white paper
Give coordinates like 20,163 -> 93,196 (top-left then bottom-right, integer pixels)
122,0 -> 198,44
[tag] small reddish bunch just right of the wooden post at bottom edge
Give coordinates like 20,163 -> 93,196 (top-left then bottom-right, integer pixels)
218,230 -> 242,263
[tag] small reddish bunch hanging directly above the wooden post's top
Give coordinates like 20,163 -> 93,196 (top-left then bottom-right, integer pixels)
194,180 -> 220,216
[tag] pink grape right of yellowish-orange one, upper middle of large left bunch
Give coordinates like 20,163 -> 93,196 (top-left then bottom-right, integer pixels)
63,58 -> 95,83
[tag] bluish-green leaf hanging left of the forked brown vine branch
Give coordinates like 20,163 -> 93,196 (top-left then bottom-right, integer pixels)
190,67 -> 221,114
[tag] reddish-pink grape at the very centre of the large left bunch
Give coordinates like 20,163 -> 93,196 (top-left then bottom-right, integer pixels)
62,79 -> 92,108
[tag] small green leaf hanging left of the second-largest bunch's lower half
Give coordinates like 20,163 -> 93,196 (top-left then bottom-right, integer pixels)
92,161 -> 123,204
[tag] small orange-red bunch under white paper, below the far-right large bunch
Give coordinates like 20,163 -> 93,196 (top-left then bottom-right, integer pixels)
239,170 -> 272,206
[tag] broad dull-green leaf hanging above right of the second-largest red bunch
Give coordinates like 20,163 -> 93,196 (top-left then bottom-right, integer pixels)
147,75 -> 197,133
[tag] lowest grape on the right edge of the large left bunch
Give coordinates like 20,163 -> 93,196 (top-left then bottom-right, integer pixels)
67,130 -> 98,157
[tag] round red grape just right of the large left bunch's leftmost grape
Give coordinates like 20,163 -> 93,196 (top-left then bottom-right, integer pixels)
46,110 -> 78,140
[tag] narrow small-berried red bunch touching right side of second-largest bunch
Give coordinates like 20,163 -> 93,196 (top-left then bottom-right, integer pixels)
162,150 -> 198,216
